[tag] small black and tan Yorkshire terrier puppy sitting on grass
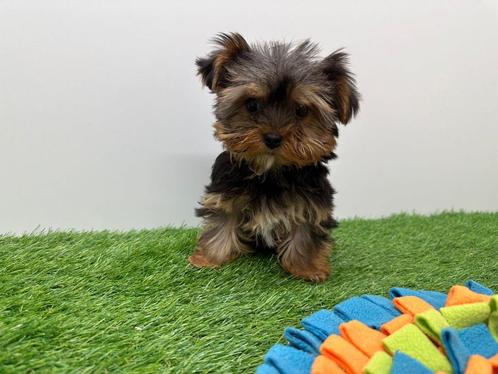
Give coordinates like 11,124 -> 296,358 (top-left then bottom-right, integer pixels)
189,33 -> 359,282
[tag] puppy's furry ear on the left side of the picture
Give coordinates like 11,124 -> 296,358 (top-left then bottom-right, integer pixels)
195,33 -> 250,92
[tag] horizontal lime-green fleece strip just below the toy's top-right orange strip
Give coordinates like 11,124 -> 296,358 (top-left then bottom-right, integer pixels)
439,303 -> 491,329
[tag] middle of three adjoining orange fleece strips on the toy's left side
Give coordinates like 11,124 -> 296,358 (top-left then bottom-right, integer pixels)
320,335 -> 369,374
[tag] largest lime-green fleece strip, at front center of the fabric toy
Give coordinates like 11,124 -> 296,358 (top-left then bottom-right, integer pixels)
383,323 -> 452,373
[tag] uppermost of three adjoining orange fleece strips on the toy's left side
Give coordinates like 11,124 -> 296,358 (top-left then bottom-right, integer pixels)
339,320 -> 386,358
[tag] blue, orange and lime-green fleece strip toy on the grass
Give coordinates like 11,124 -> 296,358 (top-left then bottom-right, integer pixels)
256,280 -> 498,374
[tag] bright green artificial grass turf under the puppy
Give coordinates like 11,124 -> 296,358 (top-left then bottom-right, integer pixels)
0,213 -> 498,373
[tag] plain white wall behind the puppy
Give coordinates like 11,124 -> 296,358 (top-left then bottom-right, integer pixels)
0,0 -> 498,233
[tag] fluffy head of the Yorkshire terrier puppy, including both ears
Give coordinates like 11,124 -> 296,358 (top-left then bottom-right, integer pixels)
196,34 -> 359,174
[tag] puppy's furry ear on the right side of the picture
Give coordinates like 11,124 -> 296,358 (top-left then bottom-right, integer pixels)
320,49 -> 360,124
